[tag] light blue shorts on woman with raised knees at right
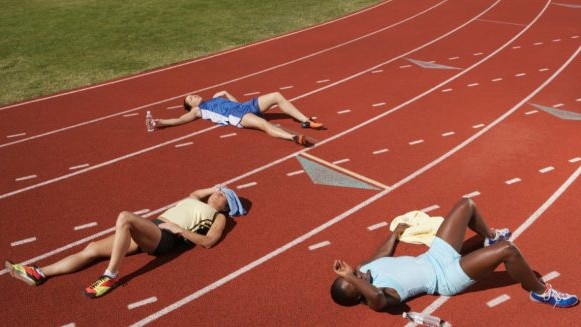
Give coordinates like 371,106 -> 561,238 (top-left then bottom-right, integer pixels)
423,237 -> 474,296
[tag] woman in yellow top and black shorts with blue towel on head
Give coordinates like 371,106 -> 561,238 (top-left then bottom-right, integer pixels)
6,186 -> 246,298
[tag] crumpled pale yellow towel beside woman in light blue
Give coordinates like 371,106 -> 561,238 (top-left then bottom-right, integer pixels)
389,211 -> 444,246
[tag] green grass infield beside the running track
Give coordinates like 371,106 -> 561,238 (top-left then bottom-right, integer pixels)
0,0 -> 378,105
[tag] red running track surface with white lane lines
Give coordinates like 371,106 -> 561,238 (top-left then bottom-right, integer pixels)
0,0 -> 581,326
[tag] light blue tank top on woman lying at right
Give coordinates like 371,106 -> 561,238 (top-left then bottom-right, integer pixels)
359,256 -> 436,302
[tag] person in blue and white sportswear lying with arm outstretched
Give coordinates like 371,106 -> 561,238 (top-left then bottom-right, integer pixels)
154,91 -> 323,146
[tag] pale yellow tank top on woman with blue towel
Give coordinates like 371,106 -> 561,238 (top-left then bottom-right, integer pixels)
161,198 -> 217,232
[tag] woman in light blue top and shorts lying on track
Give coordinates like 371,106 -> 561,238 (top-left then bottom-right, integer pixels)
331,199 -> 578,311
